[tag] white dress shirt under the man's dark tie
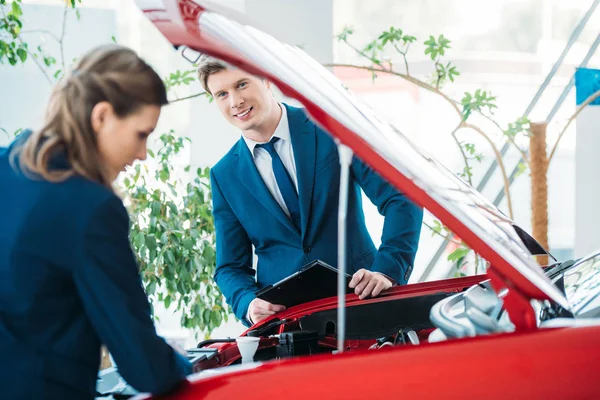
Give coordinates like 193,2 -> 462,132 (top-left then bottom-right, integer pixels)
242,105 -> 298,217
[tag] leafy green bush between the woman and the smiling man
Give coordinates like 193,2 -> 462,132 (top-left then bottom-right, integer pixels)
123,131 -> 229,335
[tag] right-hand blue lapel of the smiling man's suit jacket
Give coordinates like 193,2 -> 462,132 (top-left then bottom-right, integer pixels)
284,104 -> 317,236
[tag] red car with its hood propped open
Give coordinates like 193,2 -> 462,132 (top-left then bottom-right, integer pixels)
96,0 -> 600,400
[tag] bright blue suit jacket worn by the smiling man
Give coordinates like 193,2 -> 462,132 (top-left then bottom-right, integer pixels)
211,105 -> 423,324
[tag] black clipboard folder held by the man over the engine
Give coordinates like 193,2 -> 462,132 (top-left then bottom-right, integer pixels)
256,260 -> 354,307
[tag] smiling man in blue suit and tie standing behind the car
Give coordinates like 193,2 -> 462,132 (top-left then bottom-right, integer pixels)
198,57 -> 423,325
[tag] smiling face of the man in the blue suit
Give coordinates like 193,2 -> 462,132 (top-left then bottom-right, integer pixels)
206,68 -> 277,131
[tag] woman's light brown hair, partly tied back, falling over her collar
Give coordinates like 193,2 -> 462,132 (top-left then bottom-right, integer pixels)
11,44 -> 168,188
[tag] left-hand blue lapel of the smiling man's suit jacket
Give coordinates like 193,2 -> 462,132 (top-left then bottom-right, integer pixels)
232,139 -> 298,234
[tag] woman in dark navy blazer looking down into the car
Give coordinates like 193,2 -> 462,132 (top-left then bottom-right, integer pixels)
0,45 -> 191,399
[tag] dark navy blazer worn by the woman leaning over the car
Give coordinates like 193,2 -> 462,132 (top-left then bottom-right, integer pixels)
0,133 -> 191,399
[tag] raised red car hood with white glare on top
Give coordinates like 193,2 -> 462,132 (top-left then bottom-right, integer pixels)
137,0 -> 569,309
